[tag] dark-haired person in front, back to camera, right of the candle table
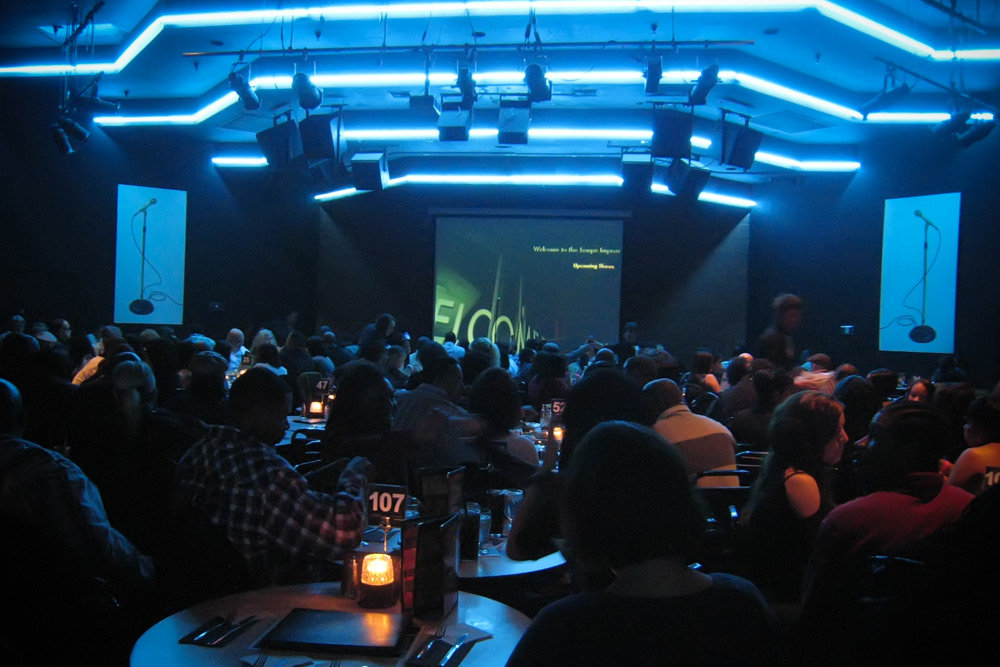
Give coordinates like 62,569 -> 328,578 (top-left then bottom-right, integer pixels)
507,426 -> 785,667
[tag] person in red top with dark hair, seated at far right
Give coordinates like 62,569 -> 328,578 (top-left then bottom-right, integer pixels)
799,401 -> 973,664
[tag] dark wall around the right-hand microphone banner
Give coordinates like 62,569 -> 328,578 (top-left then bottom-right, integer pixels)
748,128 -> 1000,387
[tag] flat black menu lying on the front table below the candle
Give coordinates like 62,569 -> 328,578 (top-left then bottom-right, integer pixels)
255,608 -> 407,655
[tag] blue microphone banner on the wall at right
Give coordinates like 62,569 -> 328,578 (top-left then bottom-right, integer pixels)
879,192 -> 962,354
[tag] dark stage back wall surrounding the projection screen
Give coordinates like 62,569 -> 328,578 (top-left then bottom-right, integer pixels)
317,179 -> 747,358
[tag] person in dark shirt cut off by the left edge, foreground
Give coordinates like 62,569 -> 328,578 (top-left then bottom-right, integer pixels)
0,380 -> 154,665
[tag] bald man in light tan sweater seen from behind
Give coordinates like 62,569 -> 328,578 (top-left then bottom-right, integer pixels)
642,379 -> 739,486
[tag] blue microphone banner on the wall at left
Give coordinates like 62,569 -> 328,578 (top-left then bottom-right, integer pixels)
115,185 -> 187,324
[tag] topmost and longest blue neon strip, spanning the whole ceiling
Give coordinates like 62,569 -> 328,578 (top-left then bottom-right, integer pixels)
0,0 -> 1000,80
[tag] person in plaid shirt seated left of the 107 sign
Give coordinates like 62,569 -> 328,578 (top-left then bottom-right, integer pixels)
175,368 -> 371,583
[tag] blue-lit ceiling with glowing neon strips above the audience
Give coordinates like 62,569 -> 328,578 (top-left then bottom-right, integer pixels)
0,0 -> 1000,180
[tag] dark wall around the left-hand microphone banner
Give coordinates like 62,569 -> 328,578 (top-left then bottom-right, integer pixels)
0,80 -> 319,336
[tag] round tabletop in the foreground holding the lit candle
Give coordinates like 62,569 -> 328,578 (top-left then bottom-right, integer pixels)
131,583 -> 531,667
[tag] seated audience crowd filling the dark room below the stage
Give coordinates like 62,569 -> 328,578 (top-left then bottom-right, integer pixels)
0,313 -> 1000,665
